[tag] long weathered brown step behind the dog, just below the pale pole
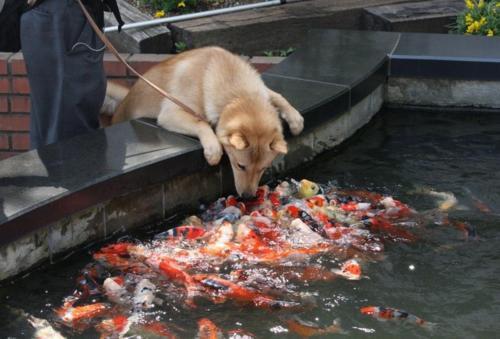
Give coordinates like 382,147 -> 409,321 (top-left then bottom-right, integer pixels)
170,0 -> 416,55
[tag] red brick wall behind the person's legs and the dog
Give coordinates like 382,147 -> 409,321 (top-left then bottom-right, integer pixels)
0,53 -> 282,160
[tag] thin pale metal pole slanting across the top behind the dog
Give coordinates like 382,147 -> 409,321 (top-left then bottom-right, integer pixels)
104,0 -> 286,33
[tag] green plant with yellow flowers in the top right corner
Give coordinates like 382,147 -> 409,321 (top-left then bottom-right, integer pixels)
453,0 -> 500,36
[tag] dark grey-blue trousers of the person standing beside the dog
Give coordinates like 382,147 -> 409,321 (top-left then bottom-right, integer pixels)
21,0 -> 106,148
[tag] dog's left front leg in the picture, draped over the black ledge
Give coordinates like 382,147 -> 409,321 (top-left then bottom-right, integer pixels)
158,102 -> 222,165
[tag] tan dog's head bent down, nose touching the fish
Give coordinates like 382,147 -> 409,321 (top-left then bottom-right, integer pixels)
217,99 -> 288,197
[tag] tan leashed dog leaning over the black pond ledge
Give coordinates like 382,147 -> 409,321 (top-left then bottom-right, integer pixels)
103,47 -> 304,197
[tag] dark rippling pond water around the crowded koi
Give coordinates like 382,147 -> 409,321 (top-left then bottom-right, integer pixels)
0,111 -> 500,338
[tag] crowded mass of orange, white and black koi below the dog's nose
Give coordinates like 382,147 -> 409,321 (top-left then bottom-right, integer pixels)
42,180 -> 475,339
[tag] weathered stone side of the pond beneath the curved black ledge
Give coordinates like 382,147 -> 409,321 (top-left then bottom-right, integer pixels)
0,85 -> 384,280
